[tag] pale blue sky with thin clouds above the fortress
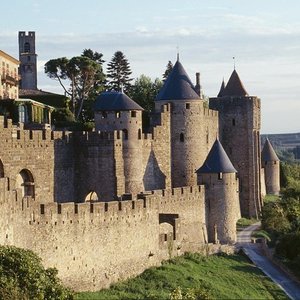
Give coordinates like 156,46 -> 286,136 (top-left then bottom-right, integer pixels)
0,0 -> 300,134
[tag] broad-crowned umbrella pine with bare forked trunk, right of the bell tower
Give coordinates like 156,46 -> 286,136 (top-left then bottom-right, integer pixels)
45,49 -> 105,120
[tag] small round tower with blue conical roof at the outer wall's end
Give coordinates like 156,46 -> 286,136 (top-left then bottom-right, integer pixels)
196,140 -> 241,244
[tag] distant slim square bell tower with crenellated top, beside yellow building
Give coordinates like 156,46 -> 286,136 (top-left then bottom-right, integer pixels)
19,31 -> 37,90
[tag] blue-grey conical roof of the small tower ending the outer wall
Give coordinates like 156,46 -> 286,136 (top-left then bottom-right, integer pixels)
196,139 -> 237,173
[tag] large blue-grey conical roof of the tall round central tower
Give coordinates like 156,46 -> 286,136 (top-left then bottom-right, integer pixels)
155,60 -> 200,101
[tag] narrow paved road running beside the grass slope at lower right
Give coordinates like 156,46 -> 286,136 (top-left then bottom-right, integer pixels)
237,223 -> 300,299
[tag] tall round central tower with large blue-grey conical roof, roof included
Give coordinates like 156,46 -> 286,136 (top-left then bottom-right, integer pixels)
155,60 -> 218,187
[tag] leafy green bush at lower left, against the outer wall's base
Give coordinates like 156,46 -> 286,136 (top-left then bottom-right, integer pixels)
0,246 -> 73,300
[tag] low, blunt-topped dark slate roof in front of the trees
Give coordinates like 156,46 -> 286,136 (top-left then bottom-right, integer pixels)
94,92 -> 144,111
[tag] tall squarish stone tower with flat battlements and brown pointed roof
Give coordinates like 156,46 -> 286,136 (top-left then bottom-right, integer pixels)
209,70 -> 261,217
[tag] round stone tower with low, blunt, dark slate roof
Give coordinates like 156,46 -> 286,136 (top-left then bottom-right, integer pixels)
95,92 -> 144,194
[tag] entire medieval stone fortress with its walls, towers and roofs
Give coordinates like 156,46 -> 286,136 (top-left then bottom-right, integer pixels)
0,32 -> 280,290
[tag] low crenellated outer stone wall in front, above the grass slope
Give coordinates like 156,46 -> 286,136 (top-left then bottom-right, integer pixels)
0,178 -> 206,290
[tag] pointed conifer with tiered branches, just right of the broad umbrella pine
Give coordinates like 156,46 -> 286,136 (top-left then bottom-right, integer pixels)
107,51 -> 133,93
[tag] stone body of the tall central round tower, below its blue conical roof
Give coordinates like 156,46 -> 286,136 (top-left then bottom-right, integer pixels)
155,100 -> 218,187
